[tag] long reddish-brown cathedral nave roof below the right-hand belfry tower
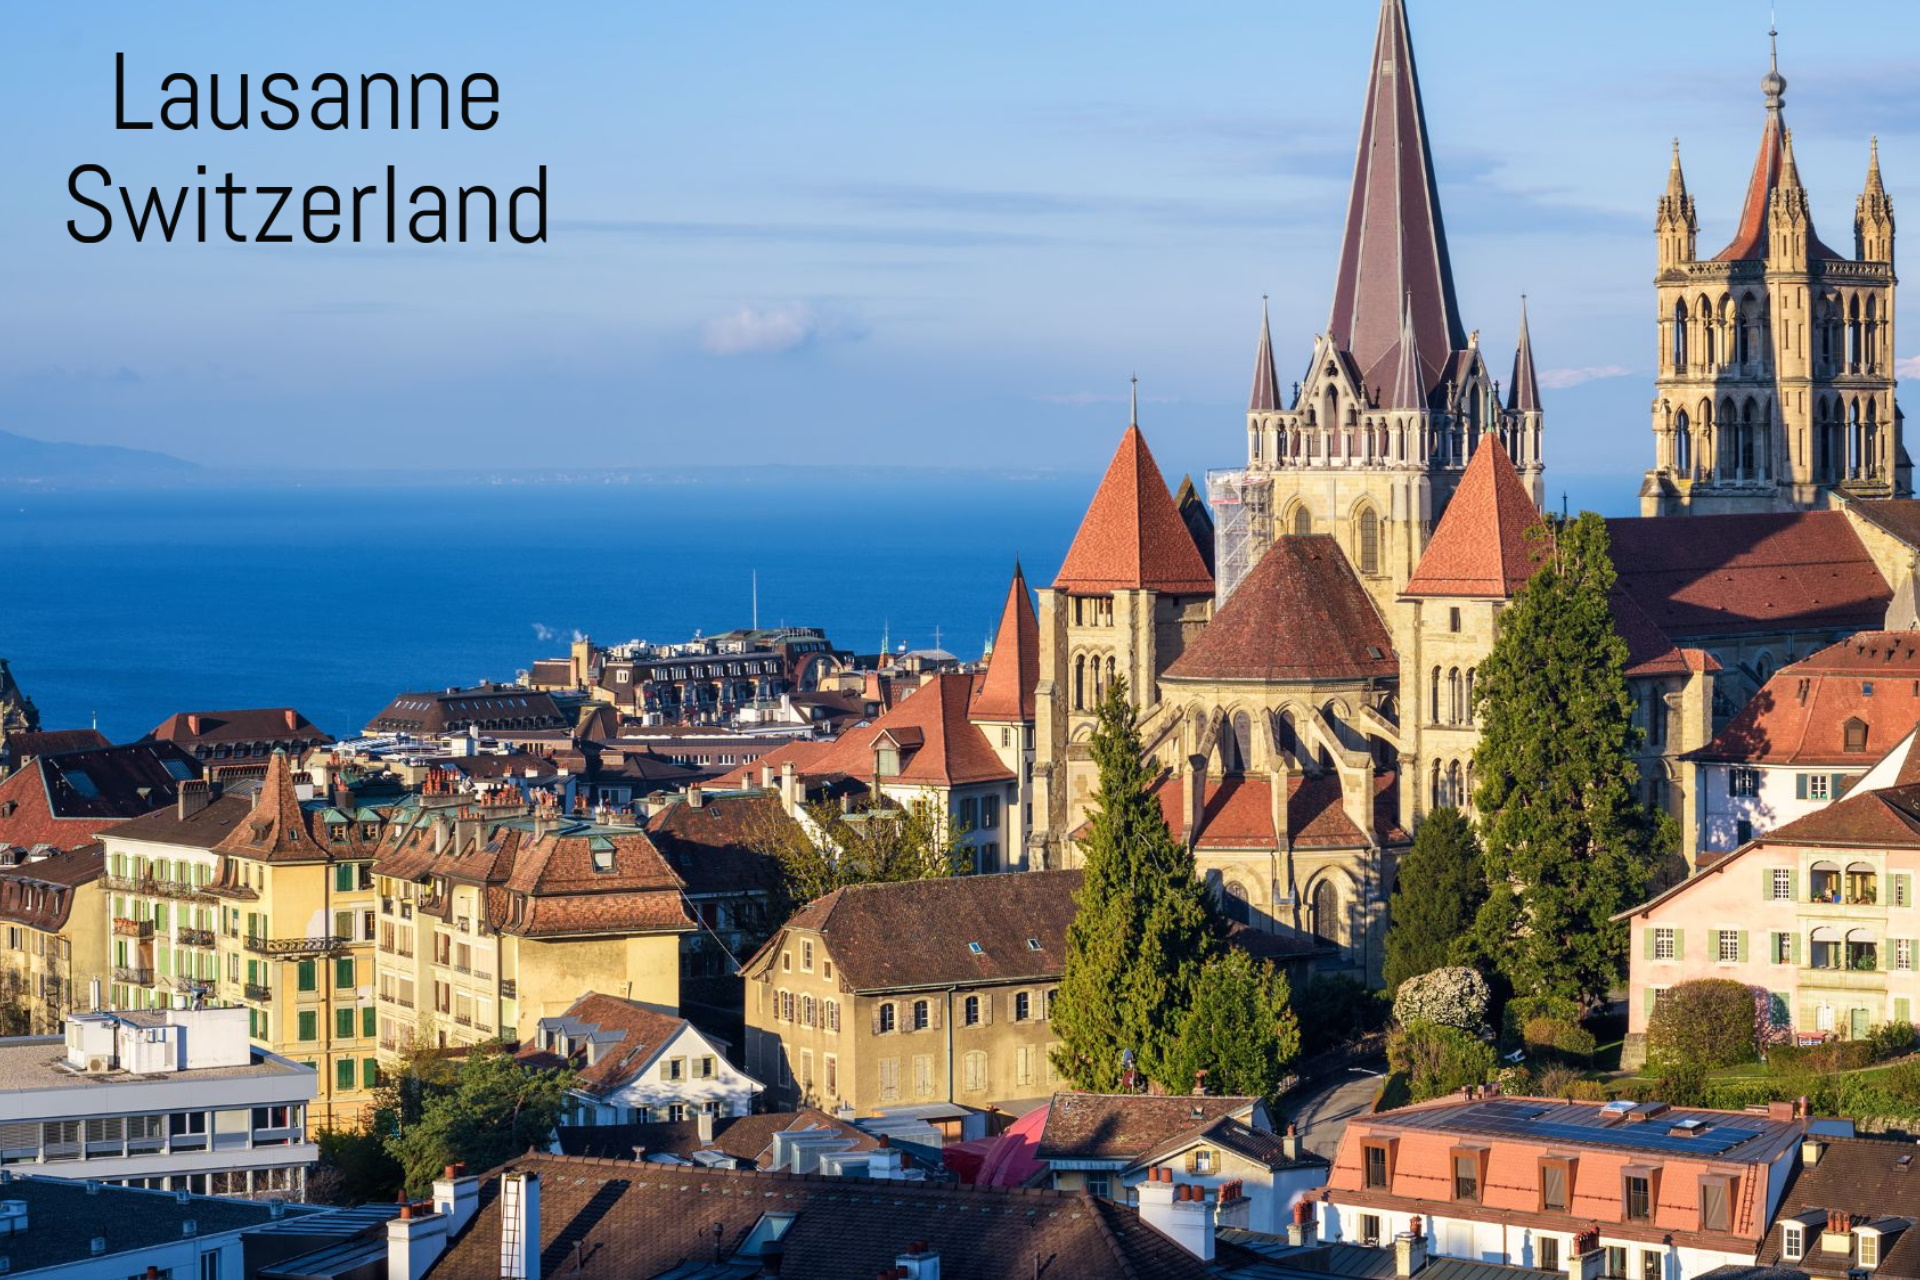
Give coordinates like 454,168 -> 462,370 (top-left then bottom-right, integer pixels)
1607,510 -> 1893,643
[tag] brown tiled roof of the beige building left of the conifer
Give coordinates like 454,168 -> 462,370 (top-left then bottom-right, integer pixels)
745,871 -> 1081,992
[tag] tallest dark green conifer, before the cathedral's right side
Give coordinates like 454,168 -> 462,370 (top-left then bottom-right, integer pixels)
1473,512 -> 1676,1002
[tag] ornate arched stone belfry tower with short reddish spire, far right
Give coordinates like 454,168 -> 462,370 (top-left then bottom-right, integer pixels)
1640,41 -> 1912,516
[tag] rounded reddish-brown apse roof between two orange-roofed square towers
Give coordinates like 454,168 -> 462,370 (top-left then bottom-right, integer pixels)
1164,535 -> 1400,681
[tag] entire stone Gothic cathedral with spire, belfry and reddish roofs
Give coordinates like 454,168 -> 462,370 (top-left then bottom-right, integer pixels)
1002,0 -> 1920,975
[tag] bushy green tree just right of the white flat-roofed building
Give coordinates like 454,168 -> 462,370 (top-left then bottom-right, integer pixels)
386,1042 -> 574,1194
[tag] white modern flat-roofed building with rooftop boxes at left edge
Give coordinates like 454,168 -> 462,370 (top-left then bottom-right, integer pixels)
0,1007 -> 319,1199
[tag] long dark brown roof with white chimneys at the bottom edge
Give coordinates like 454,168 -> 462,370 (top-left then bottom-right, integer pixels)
430,1155 -> 1206,1280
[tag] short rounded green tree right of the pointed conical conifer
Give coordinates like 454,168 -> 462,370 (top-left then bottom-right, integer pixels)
1167,948 -> 1300,1098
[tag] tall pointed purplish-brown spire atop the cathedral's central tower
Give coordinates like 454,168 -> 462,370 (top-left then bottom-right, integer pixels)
1329,0 -> 1467,401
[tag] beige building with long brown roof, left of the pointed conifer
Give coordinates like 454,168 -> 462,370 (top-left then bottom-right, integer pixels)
743,871 -> 1081,1113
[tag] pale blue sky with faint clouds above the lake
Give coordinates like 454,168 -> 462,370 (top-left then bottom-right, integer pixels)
0,0 -> 1920,486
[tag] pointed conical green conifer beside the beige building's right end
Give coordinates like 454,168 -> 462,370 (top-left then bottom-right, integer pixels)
1054,679 -> 1221,1092
